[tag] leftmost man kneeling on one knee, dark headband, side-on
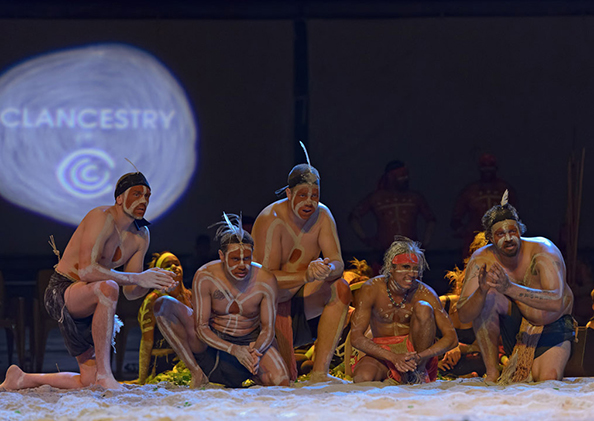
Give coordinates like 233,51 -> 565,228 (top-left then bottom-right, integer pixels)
1,172 -> 175,389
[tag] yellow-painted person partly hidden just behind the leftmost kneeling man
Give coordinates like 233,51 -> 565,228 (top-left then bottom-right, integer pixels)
138,251 -> 192,384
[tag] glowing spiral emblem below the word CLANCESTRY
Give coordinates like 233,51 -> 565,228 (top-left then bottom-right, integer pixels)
56,149 -> 115,199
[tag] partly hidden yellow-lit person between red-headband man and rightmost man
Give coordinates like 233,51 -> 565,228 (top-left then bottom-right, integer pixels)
439,232 -> 487,377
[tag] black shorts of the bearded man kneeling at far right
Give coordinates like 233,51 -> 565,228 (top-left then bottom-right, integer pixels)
499,301 -> 575,358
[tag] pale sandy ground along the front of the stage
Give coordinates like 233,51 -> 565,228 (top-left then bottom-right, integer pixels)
0,378 -> 594,421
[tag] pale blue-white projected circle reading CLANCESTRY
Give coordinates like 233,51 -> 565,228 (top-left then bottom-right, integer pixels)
0,44 -> 197,224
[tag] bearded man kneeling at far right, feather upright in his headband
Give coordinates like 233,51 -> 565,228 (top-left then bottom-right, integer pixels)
458,192 -> 575,384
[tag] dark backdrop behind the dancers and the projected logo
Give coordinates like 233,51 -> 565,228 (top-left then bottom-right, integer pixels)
0,10 -> 594,296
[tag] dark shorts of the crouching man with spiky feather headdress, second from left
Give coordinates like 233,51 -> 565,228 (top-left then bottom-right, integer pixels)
194,327 -> 260,387
